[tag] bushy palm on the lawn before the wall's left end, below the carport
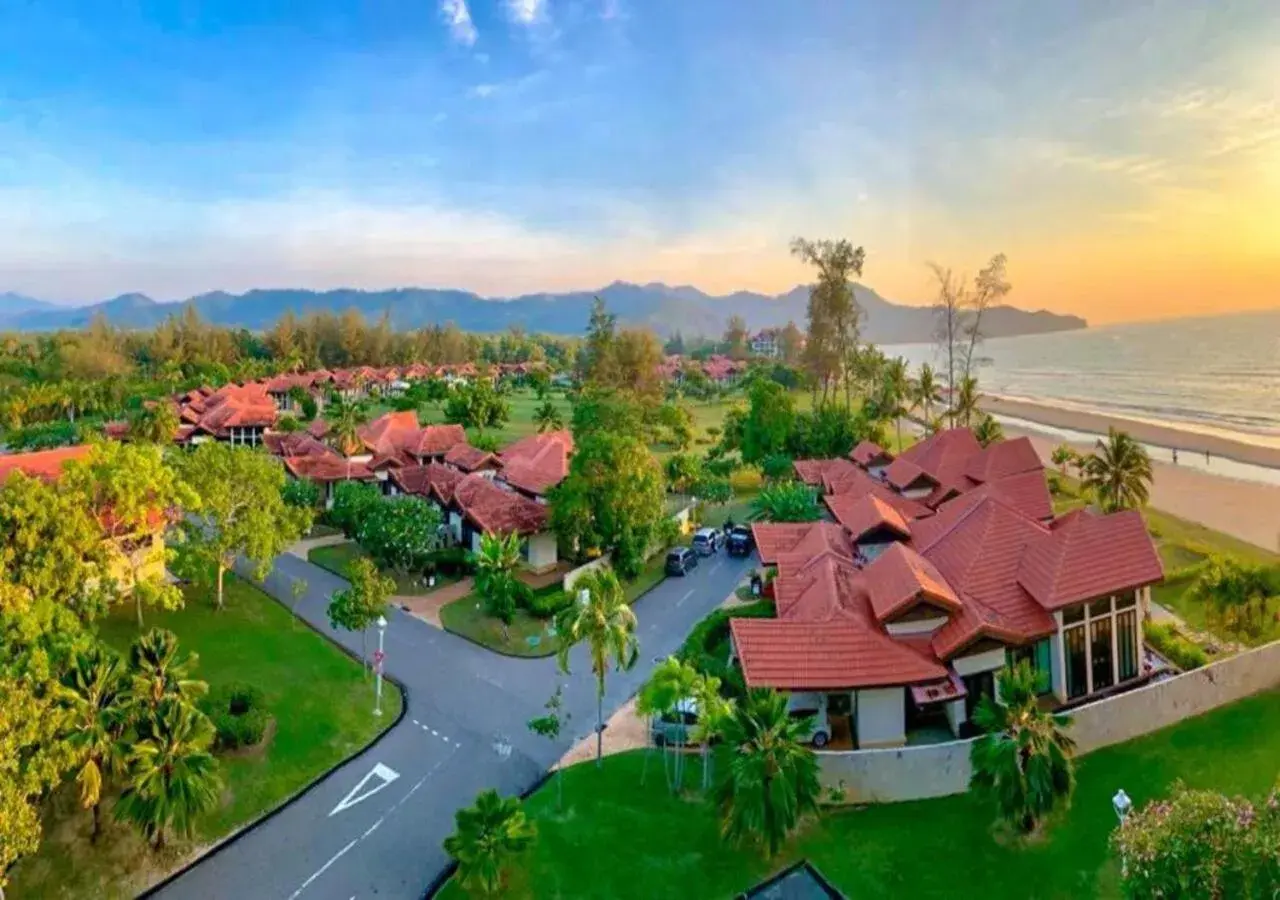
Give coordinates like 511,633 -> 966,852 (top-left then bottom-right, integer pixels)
716,687 -> 822,856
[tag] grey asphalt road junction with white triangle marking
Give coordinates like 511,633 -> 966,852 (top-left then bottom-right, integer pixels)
159,552 -> 753,900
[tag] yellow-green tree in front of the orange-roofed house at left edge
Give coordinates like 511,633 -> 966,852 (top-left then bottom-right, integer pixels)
63,440 -> 200,629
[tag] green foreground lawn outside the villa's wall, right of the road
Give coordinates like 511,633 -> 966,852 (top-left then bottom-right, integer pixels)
442,690 -> 1280,900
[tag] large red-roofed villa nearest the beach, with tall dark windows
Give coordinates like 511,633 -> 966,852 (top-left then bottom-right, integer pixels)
730,429 -> 1164,748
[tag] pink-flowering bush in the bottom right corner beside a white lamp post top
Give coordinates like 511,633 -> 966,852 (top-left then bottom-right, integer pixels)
1111,783 -> 1280,897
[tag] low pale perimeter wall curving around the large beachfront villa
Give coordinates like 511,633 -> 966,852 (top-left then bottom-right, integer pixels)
818,641 -> 1280,803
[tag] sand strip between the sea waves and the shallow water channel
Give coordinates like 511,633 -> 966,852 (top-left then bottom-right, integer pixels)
980,396 -> 1280,471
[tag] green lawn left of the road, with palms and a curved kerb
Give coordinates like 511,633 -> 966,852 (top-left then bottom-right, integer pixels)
10,575 -> 401,897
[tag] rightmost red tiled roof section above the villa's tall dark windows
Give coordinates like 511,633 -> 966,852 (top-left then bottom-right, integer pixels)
1018,510 -> 1165,609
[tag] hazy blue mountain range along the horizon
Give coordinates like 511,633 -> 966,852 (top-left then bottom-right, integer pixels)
0,282 -> 1087,343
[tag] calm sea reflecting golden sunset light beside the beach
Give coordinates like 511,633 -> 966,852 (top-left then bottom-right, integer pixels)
883,310 -> 1280,447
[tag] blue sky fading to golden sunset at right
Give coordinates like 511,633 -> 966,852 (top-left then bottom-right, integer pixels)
0,0 -> 1280,323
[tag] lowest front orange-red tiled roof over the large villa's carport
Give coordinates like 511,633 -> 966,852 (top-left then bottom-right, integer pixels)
730,618 -> 947,690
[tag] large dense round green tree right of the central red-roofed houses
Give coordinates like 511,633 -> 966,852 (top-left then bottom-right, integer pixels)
550,431 -> 666,577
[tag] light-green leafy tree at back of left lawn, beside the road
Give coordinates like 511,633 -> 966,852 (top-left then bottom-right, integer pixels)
180,440 -> 314,609
